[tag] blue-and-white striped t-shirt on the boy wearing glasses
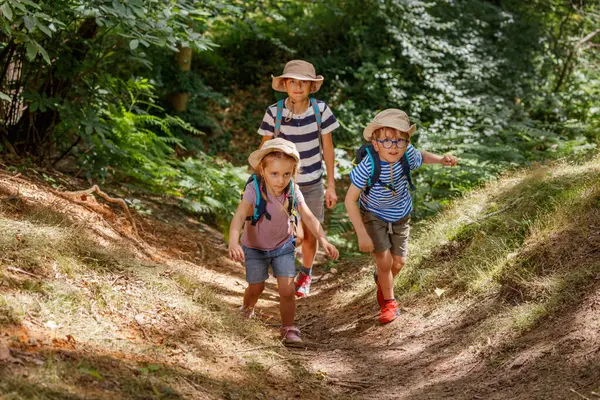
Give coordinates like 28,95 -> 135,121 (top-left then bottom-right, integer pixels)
350,144 -> 423,222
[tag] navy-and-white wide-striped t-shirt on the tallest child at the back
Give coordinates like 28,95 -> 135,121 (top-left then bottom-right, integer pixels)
258,100 -> 340,186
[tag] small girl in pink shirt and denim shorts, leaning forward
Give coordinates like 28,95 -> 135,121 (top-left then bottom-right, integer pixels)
229,138 -> 339,344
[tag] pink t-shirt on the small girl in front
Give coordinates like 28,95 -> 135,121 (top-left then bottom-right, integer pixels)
242,184 -> 304,251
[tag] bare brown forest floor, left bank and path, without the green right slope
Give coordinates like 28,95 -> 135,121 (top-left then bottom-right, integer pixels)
0,163 -> 600,399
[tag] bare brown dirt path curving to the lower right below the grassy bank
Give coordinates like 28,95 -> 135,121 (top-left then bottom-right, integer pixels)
254,258 -> 600,399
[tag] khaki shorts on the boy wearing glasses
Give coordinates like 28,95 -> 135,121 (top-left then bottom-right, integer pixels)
360,209 -> 410,257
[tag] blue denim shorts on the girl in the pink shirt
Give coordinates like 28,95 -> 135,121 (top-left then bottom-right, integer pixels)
242,239 -> 296,284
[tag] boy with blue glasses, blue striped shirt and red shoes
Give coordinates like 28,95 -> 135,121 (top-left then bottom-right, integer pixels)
345,109 -> 458,324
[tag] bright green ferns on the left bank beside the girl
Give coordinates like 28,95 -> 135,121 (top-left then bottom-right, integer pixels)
70,80 -> 247,223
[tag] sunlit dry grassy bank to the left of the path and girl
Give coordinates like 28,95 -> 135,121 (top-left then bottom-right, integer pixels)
0,193 -> 336,399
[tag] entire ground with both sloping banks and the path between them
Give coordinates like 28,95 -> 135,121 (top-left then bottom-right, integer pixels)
0,154 -> 600,399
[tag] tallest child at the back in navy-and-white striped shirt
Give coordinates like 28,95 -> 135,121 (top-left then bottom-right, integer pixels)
258,60 -> 340,297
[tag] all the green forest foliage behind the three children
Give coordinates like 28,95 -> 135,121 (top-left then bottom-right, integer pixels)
0,0 -> 600,228
